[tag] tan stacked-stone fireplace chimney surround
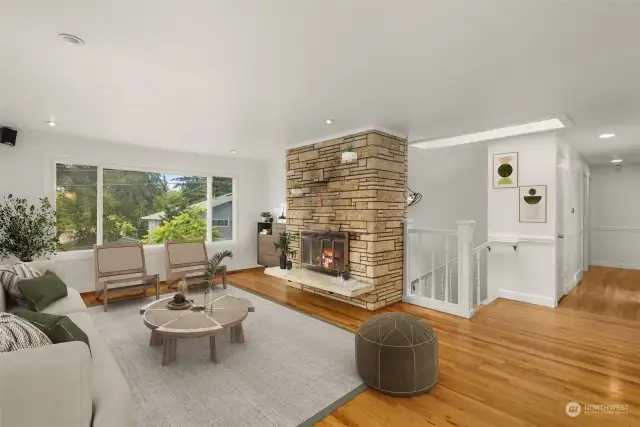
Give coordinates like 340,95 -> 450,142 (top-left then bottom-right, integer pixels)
286,130 -> 407,310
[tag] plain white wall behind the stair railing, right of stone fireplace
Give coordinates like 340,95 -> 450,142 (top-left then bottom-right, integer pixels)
408,143 -> 489,299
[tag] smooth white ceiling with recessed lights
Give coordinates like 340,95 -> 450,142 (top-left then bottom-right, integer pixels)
0,0 -> 640,163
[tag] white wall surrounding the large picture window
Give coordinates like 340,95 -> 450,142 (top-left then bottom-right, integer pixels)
0,131 -> 268,292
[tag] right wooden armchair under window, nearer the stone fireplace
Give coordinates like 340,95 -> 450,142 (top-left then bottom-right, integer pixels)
164,240 -> 227,289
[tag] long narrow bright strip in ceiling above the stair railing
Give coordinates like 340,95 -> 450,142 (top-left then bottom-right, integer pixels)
410,119 -> 565,150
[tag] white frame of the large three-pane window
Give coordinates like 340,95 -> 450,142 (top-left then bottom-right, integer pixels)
52,160 -> 238,254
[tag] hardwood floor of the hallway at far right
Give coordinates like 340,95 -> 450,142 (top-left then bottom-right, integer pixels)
559,267 -> 640,321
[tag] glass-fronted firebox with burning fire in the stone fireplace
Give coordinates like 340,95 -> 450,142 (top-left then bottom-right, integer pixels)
300,231 -> 349,274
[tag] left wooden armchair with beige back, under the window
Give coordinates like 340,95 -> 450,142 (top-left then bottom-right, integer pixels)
93,242 -> 160,311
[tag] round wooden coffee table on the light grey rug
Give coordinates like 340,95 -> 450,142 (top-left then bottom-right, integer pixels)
140,295 -> 255,366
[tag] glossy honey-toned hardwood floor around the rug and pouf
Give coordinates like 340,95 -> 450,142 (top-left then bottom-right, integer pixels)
81,269 -> 640,427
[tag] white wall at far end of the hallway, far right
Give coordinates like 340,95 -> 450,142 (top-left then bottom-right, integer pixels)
590,164 -> 640,269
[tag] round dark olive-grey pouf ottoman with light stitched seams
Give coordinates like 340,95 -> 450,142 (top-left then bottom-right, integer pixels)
356,313 -> 438,396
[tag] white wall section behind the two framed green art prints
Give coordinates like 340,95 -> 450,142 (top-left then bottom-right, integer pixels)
485,132 -> 557,307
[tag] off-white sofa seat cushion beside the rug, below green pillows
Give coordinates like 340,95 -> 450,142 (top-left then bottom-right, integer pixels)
68,313 -> 133,427
